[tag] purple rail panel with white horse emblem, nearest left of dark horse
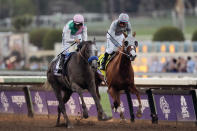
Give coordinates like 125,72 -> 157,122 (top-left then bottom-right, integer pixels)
31,91 -> 48,114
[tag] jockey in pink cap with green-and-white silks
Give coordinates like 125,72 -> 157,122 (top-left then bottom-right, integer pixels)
57,14 -> 87,73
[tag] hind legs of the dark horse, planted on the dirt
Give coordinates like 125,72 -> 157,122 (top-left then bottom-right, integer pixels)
55,87 -> 72,128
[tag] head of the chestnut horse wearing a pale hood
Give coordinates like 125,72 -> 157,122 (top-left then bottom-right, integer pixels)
122,36 -> 138,61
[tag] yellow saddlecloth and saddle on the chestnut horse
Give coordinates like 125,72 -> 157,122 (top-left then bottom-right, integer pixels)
98,53 -> 116,77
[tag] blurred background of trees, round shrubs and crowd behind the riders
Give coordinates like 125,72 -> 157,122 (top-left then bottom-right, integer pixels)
0,0 -> 197,74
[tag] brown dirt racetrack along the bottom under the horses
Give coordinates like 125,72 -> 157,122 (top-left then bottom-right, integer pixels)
0,115 -> 197,131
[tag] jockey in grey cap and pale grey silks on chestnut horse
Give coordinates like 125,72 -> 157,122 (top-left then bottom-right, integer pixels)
100,13 -> 131,70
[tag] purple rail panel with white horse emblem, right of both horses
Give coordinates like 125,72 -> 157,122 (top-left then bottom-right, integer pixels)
154,95 -> 177,121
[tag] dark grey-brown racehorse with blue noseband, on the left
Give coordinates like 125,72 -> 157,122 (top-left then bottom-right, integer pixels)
47,41 -> 109,128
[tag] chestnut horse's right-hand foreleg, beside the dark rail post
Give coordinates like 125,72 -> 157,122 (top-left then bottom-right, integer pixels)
131,85 -> 142,117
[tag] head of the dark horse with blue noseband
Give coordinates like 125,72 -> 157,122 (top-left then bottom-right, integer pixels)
81,41 -> 98,69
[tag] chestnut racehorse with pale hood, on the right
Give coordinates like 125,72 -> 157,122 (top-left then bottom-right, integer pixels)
101,34 -> 142,119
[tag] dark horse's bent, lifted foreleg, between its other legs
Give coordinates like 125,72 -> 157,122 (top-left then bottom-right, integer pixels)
72,83 -> 88,119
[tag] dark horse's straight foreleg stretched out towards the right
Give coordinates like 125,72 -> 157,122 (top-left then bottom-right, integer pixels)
88,82 -> 111,120
